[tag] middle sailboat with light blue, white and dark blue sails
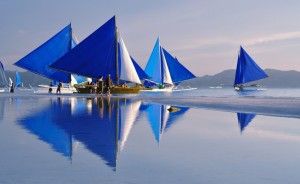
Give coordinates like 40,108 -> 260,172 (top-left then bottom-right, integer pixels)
144,38 -> 196,91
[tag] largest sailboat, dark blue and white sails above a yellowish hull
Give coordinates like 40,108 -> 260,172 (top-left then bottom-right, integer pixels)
50,16 -> 148,94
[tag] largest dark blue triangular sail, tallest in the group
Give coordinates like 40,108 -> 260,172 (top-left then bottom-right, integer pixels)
50,17 -> 117,80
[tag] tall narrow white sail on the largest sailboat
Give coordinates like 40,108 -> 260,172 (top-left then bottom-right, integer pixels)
119,36 -> 141,84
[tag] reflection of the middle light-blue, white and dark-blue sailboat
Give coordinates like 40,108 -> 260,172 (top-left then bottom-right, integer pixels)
146,104 -> 189,143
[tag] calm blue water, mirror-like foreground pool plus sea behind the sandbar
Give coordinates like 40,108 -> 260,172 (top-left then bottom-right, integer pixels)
0,89 -> 300,184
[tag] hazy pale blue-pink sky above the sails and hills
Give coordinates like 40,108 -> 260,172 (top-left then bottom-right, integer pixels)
0,0 -> 300,76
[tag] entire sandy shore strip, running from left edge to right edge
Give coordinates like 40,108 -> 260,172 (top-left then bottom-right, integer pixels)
0,93 -> 300,118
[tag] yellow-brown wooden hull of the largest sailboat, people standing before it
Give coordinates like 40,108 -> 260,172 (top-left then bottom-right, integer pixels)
74,84 -> 144,94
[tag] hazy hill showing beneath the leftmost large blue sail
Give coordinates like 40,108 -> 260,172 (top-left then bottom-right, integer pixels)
5,71 -> 51,87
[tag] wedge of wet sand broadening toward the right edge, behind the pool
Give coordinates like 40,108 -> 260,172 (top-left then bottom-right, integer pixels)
138,97 -> 300,118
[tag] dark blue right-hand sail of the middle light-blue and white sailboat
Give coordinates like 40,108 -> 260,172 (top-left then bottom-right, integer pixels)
162,48 -> 196,83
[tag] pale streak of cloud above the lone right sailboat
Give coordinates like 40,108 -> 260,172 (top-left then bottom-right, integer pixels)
244,31 -> 300,46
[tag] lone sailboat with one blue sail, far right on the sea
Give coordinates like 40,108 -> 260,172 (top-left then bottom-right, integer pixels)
234,46 -> 268,90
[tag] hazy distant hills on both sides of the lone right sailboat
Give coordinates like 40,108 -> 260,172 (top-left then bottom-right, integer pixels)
182,69 -> 300,88
